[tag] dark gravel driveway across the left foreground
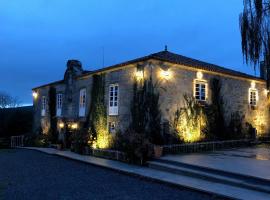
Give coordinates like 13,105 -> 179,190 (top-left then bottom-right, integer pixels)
0,149 -> 219,200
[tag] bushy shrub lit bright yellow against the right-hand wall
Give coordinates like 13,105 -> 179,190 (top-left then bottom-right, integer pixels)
174,95 -> 207,142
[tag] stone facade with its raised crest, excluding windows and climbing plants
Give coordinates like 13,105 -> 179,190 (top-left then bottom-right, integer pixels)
33,50 -> 269,138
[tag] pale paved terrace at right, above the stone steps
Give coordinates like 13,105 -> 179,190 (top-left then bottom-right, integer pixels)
162,146 -> 270,180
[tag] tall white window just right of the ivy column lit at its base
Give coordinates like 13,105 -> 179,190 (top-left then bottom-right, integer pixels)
109,84 -> 119,115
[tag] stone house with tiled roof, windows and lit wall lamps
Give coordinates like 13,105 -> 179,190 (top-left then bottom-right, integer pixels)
33,50 -> 269,141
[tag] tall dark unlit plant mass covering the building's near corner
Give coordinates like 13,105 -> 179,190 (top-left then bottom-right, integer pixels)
117,77 -> 163,164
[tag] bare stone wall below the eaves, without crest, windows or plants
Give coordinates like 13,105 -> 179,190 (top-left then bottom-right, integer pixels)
34,60 -> 269,138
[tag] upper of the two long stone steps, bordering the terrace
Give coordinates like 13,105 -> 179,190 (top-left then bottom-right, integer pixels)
156,158 -> 270,185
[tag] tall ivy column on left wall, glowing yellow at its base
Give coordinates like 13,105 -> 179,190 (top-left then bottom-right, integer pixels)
89,74 -> 112,148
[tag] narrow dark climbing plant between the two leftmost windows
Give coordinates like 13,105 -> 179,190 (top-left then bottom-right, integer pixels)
48,87 -> 58,143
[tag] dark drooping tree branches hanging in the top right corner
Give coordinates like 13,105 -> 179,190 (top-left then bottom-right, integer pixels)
239,0 -> 270,88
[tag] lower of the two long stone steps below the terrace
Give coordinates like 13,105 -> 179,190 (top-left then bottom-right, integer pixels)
148,161 -> 270,193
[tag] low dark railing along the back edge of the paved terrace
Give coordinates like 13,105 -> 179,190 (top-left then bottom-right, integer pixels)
163,140 -> 252,154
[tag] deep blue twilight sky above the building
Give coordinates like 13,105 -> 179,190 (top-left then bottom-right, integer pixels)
0,0 -> 254,103
